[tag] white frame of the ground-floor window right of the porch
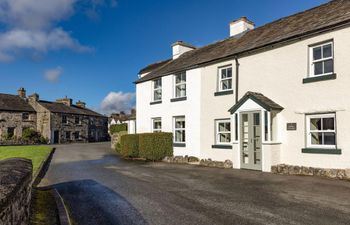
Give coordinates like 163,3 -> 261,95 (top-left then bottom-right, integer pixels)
306,113 -> 337,149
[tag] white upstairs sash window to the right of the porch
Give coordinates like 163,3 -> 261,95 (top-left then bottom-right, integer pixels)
310,42 -> 334,76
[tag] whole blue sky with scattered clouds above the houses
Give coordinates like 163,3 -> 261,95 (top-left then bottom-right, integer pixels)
0,0 -> 327,113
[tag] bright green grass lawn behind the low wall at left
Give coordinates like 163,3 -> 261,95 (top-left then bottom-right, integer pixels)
0,146 -> 52,174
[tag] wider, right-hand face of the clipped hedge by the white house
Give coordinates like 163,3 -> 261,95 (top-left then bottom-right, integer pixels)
139,132 -> 173,161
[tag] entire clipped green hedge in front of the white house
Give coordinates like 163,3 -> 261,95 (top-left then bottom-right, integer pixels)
117,132 -> 173,161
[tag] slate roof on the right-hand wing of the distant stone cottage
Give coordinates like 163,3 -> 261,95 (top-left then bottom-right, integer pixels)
39,101 -> 105,117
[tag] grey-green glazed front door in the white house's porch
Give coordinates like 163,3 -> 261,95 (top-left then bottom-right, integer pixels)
240,111 -> 262,170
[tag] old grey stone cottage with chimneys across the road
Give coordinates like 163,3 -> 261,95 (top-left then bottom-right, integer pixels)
0,88 -> 109,144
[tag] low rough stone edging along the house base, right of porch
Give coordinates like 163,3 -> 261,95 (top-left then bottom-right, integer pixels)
271,164 -> 350,180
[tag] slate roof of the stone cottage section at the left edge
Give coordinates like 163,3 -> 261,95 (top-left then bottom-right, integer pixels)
0,94 -> 35,112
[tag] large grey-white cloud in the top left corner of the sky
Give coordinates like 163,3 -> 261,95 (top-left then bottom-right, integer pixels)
0,0 -> 116,61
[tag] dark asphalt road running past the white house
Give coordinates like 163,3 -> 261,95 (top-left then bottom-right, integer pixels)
41,143 -> 350,225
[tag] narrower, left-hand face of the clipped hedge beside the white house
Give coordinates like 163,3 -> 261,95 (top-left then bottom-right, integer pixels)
120,134 -> 139,158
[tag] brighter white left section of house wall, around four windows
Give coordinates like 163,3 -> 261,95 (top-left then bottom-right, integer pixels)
136,69 -> 201,157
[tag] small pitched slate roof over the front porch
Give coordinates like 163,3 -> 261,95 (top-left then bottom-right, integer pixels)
229,91 -> 283,114
